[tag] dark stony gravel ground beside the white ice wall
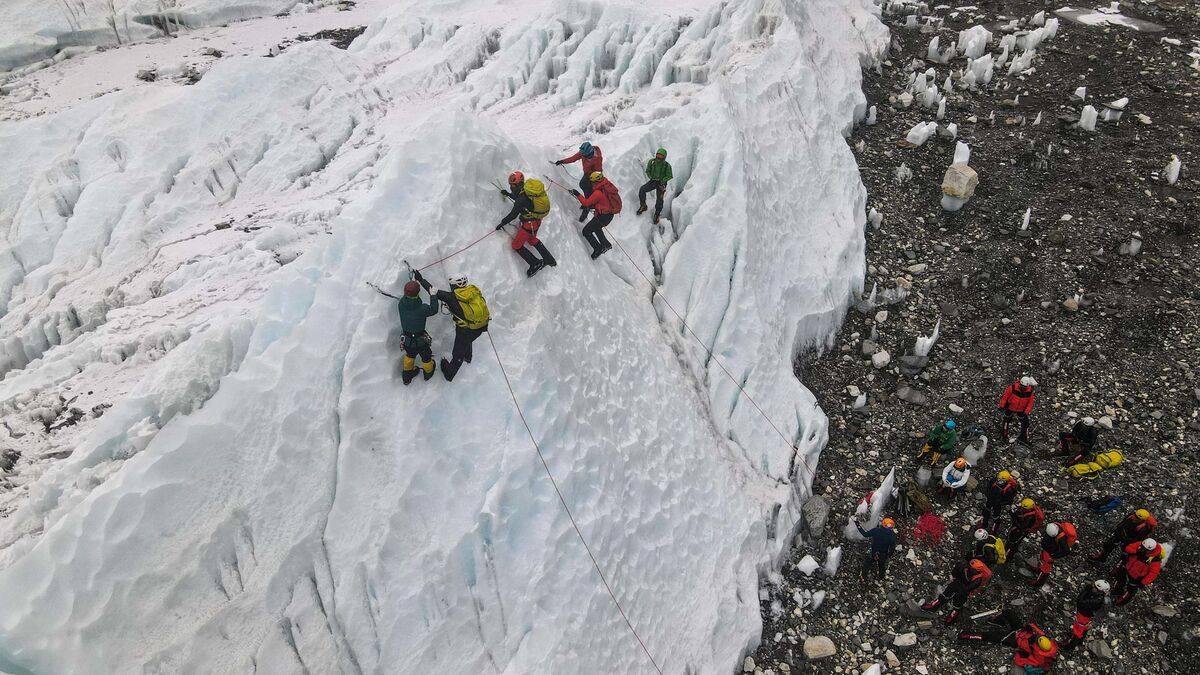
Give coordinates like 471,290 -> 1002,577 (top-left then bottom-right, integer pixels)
746,0 -> 1200,674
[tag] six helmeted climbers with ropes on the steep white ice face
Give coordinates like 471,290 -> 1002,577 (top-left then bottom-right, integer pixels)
397,142 -> 674,384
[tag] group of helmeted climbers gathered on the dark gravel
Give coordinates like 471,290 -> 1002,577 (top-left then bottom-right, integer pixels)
854,376 -> 1164,674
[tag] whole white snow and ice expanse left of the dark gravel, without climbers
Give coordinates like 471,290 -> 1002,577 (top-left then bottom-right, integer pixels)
0,0 -> 887,673
